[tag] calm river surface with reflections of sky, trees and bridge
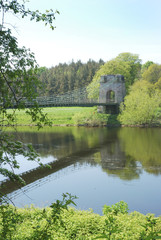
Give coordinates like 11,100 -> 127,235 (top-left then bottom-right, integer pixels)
1,127 -> 161,216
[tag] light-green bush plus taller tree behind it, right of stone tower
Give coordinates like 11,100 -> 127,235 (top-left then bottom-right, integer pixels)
119,61 -> 161,125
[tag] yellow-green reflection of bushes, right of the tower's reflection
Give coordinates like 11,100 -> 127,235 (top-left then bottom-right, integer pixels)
118,128 -> 161,175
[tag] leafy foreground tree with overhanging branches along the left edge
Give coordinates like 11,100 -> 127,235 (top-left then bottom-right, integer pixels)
0,0 -> 58,199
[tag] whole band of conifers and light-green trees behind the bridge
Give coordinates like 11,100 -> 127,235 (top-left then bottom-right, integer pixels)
38,52 -> 161,125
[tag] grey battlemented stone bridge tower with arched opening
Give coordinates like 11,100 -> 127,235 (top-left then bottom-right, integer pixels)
98,74 -> 126,113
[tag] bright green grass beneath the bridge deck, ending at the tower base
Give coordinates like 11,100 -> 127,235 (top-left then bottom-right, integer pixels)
5,107 -> 119,126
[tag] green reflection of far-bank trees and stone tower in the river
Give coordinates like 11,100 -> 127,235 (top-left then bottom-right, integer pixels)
9,127 -> 161,176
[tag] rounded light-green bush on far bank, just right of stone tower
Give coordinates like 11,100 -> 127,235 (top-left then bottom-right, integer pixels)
119,80 -> 161,125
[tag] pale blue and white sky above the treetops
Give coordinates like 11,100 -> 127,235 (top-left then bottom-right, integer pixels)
6,0 -> 161,68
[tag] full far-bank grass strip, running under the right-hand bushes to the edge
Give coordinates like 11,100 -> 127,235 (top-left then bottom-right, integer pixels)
3,107 -> 161,127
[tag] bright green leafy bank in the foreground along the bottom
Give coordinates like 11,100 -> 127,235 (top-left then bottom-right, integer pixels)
0,201 -> 161,240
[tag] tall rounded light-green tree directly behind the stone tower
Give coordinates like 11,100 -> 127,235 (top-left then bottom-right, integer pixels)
87,53 -> 141,99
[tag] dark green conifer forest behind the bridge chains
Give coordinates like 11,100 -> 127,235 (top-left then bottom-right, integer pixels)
38,59 -> 104,96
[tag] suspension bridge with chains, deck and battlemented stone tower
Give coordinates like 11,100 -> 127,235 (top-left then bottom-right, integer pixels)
25,75 -> 125,113
